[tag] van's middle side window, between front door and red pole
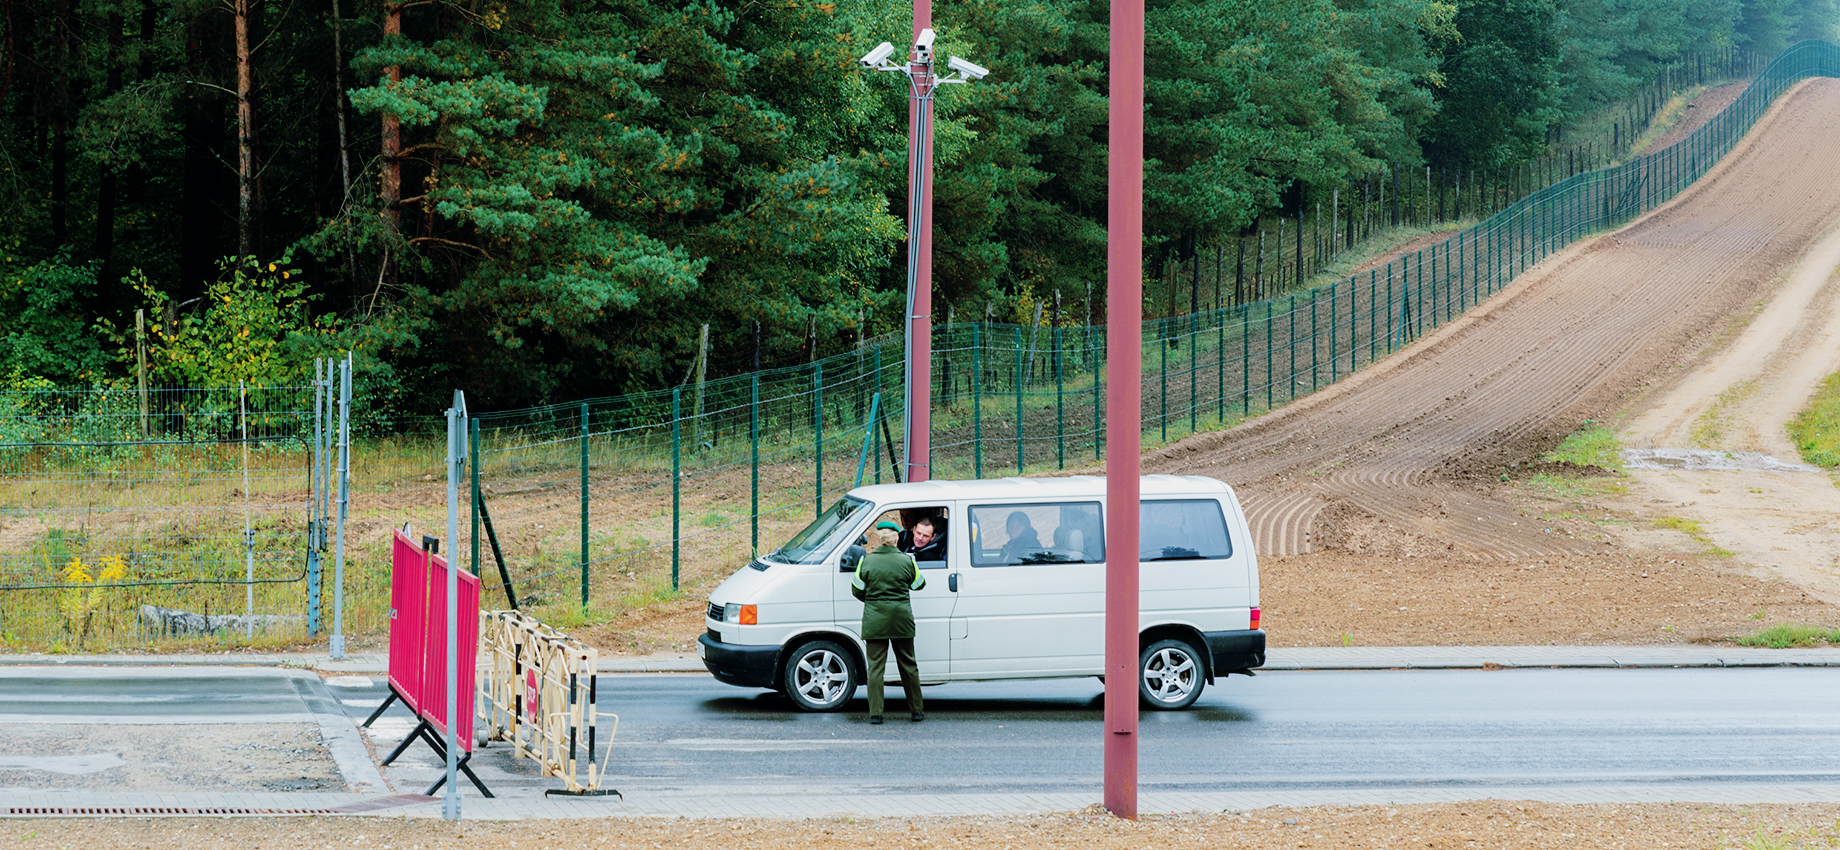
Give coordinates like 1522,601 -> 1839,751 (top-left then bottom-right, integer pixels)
970,502 -> 1106,567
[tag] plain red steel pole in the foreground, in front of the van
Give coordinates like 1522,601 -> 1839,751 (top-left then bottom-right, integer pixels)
1104,0 -> 1144,821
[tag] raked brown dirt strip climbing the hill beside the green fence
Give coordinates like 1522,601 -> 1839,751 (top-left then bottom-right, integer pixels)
1144,79 -> 1840,557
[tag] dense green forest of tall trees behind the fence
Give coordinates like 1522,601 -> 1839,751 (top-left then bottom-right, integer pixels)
0,0 -> 1834,408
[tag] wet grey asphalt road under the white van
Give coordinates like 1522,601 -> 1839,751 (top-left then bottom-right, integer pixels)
329,668 -> 1840,795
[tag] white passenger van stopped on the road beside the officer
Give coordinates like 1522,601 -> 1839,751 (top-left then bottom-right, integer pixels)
697,475 -> 1266,712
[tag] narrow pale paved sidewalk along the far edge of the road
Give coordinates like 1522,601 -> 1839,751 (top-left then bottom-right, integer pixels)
0,644 -> 1840,673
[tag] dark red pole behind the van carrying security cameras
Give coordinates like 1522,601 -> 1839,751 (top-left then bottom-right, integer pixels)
903,0 -> 933,480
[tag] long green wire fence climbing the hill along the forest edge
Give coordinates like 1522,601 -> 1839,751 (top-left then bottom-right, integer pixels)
471,42 -> 1840,618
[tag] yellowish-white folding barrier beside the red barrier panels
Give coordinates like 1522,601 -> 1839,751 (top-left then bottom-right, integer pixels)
480,611 -> 620,797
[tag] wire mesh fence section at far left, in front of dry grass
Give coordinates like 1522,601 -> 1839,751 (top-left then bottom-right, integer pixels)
0,386 -> 316,648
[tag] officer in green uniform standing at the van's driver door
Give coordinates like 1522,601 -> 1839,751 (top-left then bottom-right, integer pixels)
850,523 -> 926,725
